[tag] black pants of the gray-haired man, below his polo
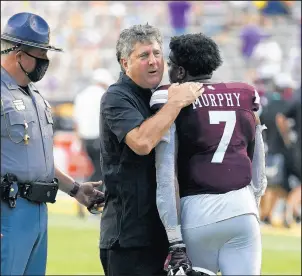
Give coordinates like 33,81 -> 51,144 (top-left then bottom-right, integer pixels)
100,247 -> 168,276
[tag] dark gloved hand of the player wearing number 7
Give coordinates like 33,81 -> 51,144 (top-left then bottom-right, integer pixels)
164,242 -> 192,276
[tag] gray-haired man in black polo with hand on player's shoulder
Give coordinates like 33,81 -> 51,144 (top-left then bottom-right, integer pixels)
100,24 -> 202,276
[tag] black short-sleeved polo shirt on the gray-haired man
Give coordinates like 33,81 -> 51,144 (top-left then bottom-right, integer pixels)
100,73 -> 167,248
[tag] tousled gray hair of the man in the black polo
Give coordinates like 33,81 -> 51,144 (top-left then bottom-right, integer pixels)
116,23 -> 163,71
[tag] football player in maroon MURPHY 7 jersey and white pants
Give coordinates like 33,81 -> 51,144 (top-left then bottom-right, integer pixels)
150,34 -> 267,275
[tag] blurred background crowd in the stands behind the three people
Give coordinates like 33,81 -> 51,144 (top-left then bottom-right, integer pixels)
1,1 -> 301,227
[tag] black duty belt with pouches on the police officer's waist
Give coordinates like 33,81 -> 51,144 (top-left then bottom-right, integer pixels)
0,173 -> 58,208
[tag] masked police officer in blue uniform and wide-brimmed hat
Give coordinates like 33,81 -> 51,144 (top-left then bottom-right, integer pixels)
0,12 -> 102,275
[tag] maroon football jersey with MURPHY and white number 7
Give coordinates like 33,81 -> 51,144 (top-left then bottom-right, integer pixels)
176,82 -> 260,197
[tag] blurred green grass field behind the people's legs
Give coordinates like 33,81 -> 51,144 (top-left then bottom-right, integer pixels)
47,213 -> 301,275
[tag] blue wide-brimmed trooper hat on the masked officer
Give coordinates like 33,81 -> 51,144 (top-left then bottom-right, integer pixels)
1,12 -> 62,54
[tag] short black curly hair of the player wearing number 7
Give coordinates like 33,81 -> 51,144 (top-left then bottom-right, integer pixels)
169,33 -> 222,77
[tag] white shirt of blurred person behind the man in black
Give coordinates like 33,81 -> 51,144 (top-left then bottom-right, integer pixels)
74,85 -> 105,140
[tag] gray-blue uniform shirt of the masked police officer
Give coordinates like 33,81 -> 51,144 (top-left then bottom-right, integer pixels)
1,67 -> 54,182
